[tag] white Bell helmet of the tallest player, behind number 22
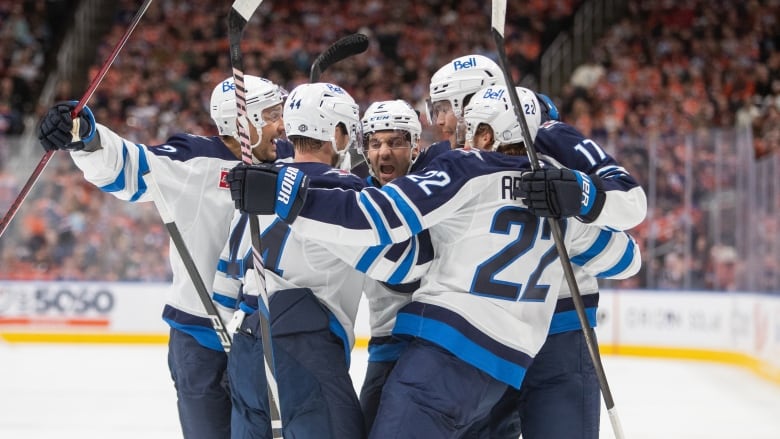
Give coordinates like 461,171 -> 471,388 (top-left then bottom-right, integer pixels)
428,54 -> 504,124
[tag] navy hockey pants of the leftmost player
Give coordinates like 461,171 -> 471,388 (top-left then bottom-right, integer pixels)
168,328 -> 231,439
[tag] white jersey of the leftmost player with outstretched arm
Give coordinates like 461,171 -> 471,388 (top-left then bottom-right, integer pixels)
71,124 -> 292,351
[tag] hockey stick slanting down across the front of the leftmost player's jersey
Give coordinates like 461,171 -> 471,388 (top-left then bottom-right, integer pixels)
143,166 -> 231,353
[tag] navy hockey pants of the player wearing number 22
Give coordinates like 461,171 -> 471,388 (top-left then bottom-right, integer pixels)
369,339 -> 508,439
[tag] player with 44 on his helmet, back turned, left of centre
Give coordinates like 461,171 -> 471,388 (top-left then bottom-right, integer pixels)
214,83 -> 365,439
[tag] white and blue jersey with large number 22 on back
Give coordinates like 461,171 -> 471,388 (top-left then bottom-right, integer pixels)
291,150 -> 641,388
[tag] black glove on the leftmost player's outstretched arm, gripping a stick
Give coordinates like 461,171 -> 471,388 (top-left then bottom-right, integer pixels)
38,101 -> 100,151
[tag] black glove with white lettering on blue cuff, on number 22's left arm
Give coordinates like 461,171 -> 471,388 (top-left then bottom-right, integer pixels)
227,163 -> 309,224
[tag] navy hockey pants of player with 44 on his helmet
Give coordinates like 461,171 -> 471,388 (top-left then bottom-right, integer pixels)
228,289 -> 365,439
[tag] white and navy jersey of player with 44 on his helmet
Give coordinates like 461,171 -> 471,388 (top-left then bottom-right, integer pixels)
214,163 -> 390,353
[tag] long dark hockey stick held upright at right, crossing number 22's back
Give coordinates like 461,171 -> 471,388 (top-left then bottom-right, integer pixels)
491,0 -> 625,439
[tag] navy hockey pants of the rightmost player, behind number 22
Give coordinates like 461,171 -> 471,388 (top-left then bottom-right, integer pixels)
467,331 -> 601,439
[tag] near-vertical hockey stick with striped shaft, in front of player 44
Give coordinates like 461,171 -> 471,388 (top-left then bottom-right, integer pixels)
228,0 -> 282,438
